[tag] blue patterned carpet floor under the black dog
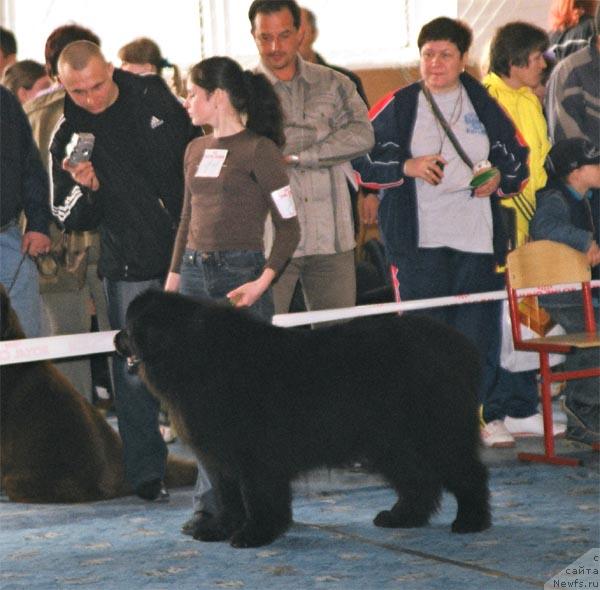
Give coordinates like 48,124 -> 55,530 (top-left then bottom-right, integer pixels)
0,441 -> 600,590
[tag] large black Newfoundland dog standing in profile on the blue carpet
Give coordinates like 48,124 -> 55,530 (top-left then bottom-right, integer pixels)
116,291 -> 491,547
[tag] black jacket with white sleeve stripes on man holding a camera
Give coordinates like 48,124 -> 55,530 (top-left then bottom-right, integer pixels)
50,69 -> 202,281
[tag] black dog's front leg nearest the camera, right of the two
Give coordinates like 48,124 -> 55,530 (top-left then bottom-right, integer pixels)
230,472 -> 292,548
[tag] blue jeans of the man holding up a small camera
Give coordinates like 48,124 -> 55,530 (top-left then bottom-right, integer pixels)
103,279 -> 167,489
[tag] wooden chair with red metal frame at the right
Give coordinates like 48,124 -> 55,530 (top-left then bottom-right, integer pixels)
506,240 -> 600,465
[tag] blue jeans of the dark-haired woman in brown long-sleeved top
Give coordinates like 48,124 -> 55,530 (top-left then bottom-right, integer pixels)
179,249 -> 273,515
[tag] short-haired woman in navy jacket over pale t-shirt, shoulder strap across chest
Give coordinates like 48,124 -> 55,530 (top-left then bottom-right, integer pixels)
354,17 -> 528,444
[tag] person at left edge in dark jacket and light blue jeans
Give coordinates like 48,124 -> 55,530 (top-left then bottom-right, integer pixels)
0,86 -> 51,338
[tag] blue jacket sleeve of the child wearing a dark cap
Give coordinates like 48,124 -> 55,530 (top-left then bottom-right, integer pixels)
529,190 -> 594,252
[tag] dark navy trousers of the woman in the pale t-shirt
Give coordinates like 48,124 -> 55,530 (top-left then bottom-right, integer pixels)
391,248 -> 504,400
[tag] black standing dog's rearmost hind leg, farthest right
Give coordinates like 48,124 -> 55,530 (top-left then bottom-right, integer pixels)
444,459 -> 492,533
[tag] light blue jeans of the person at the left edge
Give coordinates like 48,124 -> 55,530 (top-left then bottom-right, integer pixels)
0,222 -> 41,338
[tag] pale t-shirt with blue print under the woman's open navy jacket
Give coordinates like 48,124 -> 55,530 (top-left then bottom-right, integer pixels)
410,85 -> 493,254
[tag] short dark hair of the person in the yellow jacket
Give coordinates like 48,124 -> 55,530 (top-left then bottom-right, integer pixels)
490,21 -> 549,76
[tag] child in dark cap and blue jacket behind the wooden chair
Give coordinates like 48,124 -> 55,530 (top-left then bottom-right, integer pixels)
530,137 -> 600,444
